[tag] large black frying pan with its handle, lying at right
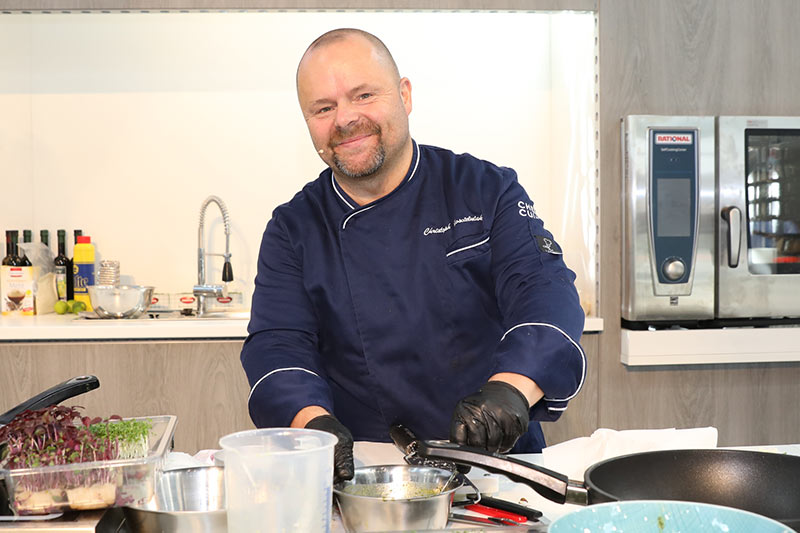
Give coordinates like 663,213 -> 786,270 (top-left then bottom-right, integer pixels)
396,428 -> 800,529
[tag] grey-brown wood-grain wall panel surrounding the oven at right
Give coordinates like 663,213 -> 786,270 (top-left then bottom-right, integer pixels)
598,0 -> 800,445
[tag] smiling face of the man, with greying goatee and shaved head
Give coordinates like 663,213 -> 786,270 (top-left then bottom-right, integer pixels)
297,36 -> 411,178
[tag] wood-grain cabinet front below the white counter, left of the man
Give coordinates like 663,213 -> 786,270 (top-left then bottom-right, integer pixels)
0,341 -> 254,454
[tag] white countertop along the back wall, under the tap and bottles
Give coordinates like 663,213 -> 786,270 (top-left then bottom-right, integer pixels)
0,314 -> 603,342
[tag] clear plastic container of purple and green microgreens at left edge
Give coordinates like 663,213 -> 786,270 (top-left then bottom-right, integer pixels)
0,406 -> 177,515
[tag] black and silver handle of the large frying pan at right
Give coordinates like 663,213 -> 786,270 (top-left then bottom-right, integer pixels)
417,440 -> 588,505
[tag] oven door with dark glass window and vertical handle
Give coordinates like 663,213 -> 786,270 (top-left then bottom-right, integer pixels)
716,116 -> 800,318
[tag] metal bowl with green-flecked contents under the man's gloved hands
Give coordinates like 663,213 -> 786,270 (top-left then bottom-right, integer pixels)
333,465 -> 463,533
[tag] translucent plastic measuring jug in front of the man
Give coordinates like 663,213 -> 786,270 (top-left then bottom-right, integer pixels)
219,428 -> 337,533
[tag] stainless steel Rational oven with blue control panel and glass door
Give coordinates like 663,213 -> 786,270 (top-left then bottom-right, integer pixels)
622,115 -> 800,327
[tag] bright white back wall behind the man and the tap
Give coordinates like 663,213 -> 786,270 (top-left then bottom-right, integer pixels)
0,12 -> 596,312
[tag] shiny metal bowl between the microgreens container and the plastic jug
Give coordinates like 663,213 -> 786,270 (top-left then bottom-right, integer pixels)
122,466 -> 228,533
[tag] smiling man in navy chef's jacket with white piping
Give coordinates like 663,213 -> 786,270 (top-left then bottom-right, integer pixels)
242,29 -> 586,479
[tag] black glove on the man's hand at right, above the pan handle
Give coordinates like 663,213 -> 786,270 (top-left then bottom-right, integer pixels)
450,381 -> 530,453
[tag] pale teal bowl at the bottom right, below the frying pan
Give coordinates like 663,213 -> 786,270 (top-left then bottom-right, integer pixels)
549,500 -> 794,533
